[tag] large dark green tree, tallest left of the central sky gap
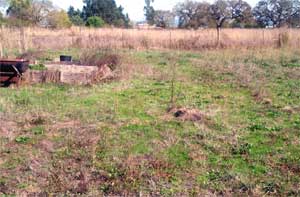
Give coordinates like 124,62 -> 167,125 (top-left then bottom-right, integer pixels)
82,0 -> 128,26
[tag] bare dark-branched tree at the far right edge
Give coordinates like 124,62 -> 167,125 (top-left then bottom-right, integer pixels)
253,0 -> 300,27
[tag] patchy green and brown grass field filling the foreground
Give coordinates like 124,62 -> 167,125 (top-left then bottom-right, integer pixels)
0,49 -> 300,196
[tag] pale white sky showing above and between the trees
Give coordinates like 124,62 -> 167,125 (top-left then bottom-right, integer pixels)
53,0 -> 258,21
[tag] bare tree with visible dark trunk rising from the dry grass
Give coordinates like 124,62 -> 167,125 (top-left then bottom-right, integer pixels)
210,0 -> 251,46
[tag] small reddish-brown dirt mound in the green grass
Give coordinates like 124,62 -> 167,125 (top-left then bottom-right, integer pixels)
168,108 -> 205,122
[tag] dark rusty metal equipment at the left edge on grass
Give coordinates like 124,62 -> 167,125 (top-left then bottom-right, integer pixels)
0,59 -> 29,86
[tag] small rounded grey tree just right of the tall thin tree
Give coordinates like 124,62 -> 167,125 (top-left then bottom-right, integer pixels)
154,10 -> 175,28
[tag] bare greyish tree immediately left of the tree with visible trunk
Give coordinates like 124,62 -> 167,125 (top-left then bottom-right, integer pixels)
174,0 -> 211,29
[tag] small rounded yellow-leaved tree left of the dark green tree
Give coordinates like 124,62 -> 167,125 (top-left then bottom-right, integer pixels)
48,10 -> 72,29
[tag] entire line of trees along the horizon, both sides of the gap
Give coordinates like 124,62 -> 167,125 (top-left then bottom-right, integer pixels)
0,0 -> 300,28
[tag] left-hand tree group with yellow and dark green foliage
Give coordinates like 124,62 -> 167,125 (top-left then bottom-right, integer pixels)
0,0 -> 130,28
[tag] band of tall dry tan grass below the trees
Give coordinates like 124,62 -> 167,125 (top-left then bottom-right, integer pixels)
0,28 -> 300,51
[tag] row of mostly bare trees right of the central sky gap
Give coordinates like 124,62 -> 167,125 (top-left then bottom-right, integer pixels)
144,0 -> 300,29
